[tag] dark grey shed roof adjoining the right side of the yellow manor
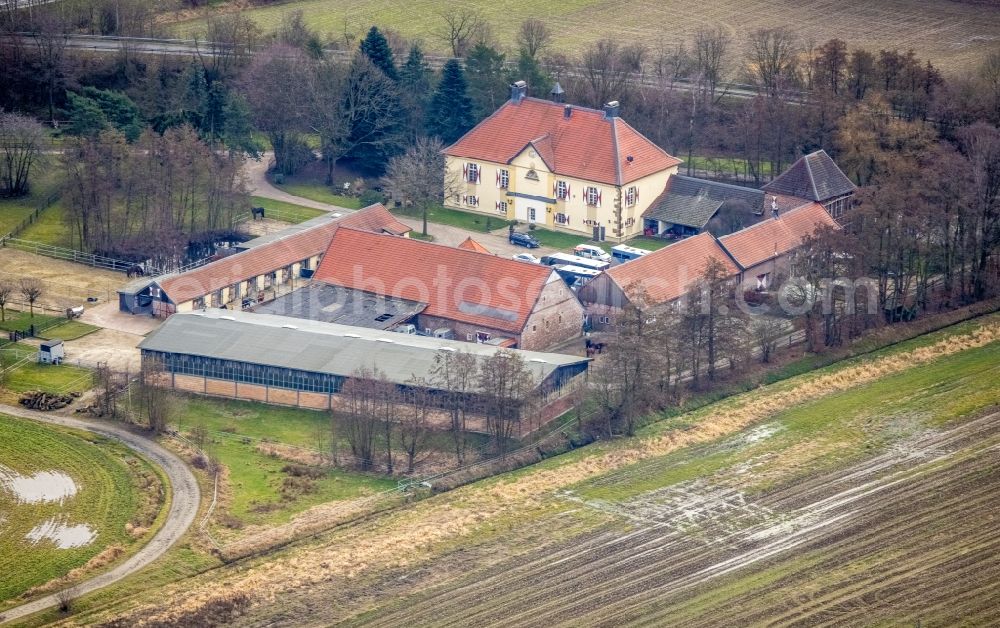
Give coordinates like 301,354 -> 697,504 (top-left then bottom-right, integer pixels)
643,174 -> 764,229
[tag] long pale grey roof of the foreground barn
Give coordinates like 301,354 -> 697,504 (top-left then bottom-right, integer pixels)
139,310 -> 588,384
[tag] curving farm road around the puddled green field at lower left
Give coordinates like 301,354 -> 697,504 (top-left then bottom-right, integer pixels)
0,404 -> 201,623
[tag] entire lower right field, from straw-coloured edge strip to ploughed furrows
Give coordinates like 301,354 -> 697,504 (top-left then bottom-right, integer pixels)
72,315 -> 1000,626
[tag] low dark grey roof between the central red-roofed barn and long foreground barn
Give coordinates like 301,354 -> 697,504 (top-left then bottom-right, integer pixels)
253,281 -> 427,329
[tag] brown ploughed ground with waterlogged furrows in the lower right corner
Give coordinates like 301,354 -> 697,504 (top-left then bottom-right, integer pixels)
361,413 -> 1000,626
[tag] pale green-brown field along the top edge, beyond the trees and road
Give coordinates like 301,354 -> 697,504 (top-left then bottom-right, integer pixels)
168,0 -> 1000,72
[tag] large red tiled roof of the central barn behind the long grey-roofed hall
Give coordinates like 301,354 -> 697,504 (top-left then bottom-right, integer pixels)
314,229 -> 558,333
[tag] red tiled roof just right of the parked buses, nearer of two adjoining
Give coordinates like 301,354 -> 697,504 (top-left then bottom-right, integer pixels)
607,233 -> 740,303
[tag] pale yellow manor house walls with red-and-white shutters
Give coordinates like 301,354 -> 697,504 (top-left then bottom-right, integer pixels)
444,146 -> 677,241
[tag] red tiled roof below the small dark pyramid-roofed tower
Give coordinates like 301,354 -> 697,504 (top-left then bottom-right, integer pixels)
716,202 -> 839,268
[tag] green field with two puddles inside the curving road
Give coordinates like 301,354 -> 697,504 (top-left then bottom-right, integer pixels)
0,415 -> 161,609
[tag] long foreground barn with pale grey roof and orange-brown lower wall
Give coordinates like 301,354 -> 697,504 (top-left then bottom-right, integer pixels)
139,310 -> 589,418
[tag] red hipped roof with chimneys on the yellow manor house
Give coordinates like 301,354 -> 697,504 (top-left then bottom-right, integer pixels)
444,98 -> 681,185
